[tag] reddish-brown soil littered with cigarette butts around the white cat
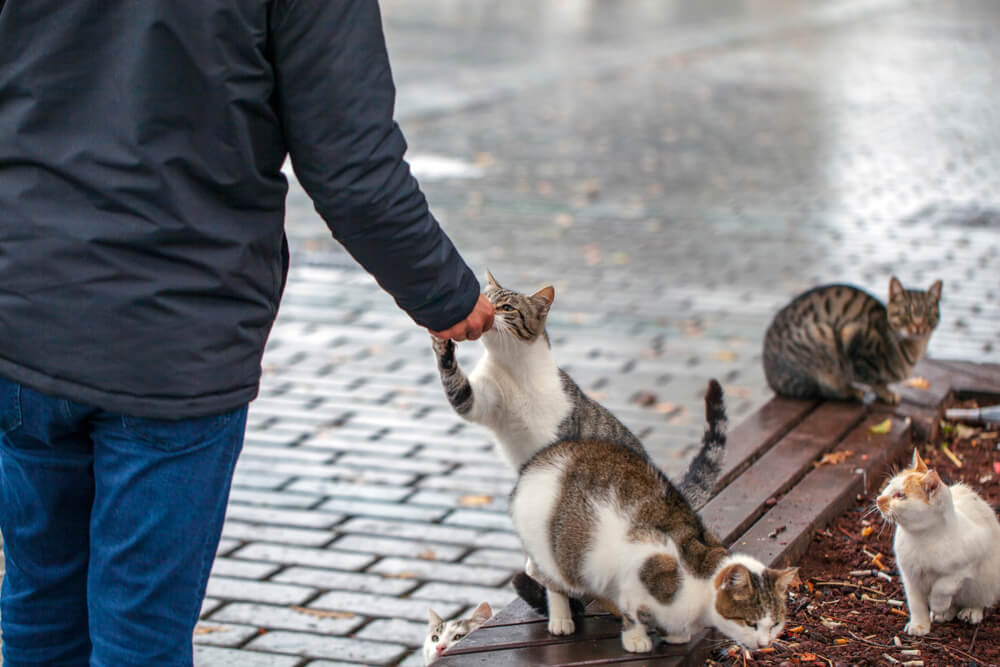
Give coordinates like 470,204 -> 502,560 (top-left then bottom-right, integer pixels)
715,404 -> 1000,667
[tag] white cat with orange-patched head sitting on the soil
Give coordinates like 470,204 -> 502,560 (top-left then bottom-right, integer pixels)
876,450 -> 1000,635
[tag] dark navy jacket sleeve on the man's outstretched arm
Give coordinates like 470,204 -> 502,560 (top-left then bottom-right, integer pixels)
270,0 -> 479,331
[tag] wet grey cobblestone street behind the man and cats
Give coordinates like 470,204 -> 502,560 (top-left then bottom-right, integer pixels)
0,0 -> 1000,667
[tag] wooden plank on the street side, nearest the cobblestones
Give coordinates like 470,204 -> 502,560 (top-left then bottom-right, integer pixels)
716,397 -> 819,490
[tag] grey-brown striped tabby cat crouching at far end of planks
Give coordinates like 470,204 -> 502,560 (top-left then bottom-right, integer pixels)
764,277 -> 941,404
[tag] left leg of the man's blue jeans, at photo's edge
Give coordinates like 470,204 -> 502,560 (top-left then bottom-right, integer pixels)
0,379 -> 94,667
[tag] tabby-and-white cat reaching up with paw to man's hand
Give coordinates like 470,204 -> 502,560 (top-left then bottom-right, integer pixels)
432,272 -> 725,508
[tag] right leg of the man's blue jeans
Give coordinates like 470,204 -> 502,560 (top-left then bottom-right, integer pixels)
87,407 -> 246,667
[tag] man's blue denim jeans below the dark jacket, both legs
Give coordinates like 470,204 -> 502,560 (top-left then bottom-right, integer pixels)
0,378 -> 246,667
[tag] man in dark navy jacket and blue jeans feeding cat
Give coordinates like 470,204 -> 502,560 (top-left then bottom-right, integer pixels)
0,0 -> 493,667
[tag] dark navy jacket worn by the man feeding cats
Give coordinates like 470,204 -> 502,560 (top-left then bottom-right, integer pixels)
0,0 -> 479,418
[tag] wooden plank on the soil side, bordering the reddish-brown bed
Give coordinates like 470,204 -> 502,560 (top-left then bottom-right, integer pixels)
733,413 -> 911,567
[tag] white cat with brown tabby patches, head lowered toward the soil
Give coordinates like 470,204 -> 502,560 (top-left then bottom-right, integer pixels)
510,380 -> 798,652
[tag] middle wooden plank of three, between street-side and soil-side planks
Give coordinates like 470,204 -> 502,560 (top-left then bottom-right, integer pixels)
701,402 -> 865,544
